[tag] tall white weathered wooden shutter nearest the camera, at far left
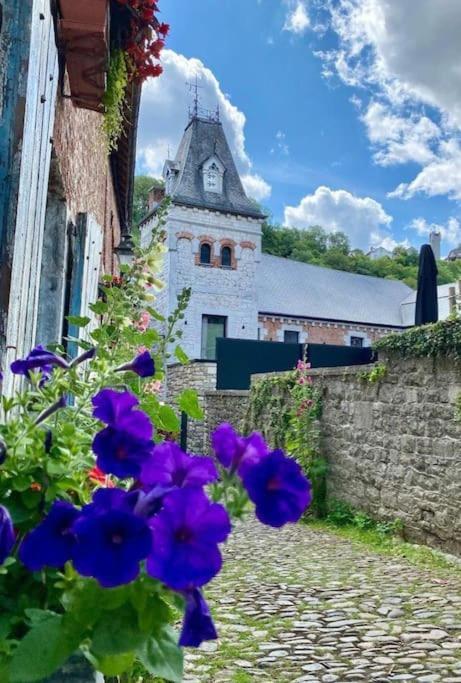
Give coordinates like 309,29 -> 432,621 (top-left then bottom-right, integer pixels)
3,0 -> 58,393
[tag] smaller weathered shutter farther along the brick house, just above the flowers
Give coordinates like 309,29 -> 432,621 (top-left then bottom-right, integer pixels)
67,213 -> 103,357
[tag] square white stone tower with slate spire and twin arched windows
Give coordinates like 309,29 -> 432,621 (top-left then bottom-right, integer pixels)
141,115 -> 264,359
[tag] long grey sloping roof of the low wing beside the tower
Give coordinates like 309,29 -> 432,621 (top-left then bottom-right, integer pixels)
256,254 -> 413,327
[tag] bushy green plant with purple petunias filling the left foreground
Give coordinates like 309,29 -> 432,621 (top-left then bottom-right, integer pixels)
0,206 -> 311,683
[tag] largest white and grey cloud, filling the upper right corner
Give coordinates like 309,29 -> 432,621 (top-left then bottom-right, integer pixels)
317,0 -> 461,199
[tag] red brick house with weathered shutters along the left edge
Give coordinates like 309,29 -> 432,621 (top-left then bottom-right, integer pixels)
0,0 -> 140,391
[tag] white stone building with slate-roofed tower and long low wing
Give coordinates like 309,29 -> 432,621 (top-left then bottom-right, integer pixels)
141,116 -> 440,359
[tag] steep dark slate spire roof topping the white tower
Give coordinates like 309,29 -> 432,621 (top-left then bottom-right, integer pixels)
164,116 -> 264,219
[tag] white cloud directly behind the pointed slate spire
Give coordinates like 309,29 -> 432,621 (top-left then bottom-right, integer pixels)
138,50 -> 271,200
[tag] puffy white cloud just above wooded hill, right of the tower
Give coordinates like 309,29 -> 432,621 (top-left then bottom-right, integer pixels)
285,186 -> 392,249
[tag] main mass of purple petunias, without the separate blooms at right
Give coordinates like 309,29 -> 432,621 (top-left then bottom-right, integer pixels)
18,389 -> 231,645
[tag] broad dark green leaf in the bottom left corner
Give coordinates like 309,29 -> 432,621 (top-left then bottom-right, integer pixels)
10,614 -> 83,683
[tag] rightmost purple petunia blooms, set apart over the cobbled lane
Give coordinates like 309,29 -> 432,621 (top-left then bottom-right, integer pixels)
212,424 -> 312,527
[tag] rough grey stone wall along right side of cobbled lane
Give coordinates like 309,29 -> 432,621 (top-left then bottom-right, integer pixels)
251,358 -> 461,553
